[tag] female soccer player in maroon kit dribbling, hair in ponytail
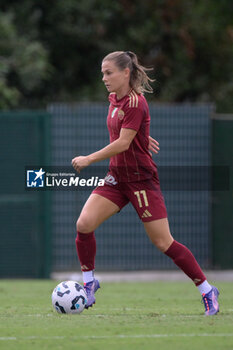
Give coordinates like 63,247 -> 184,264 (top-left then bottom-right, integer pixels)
72,51 -> 219,315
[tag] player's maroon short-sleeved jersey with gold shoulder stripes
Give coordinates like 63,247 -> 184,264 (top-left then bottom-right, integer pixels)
107,90 -> 157,182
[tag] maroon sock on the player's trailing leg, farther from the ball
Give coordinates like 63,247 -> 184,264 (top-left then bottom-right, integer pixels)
165,241 -> 206,286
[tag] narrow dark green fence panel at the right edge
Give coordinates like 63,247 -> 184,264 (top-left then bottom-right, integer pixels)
211,114 -> 233,268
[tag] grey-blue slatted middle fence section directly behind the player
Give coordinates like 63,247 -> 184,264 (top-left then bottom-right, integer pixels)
48,103 -> 212,270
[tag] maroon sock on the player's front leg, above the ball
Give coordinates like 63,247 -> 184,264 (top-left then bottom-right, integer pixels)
75,232 -> 96,271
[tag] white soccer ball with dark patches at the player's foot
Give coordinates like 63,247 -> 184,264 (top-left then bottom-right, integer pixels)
52,281 -> 87,314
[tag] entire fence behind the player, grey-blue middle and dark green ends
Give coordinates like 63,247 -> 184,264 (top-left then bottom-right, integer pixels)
0,103 -> 233,277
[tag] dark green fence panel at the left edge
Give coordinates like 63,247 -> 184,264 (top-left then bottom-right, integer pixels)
0,112 -> 51,277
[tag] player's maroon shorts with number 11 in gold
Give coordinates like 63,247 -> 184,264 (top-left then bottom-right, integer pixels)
92,177 -> 167,222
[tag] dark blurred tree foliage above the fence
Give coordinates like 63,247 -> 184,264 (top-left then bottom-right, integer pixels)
0,0 -> 233,112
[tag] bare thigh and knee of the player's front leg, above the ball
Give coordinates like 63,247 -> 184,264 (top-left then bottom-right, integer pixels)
77,193 -> 120,233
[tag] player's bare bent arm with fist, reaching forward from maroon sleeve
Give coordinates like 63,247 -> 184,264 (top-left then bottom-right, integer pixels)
72,128 -> 137,172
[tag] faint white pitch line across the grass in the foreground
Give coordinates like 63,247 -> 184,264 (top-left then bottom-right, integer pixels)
0,333 -> 233,341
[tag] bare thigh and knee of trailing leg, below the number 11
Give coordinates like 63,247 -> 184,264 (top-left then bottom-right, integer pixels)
143,218 -> 174,252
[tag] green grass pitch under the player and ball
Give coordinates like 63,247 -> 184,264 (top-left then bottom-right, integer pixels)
0,280 -> 233,350
